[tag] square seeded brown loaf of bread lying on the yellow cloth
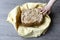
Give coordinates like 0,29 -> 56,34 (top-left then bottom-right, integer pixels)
21,8 -> 43,26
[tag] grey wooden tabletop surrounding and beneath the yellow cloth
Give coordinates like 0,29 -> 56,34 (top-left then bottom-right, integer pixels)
0,0 -> 60,40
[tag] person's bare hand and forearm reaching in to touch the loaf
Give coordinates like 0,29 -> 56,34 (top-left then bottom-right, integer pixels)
40,0 -> 56,15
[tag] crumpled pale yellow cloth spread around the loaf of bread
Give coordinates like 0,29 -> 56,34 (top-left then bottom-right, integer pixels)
7,3 -> 51,38
